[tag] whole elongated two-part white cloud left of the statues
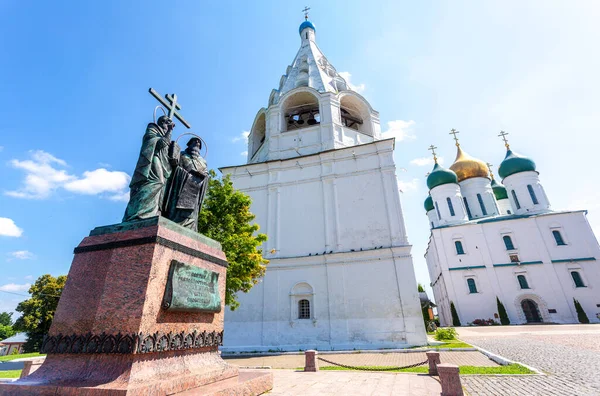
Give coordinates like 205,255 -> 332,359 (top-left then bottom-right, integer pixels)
5,150 -> 130,199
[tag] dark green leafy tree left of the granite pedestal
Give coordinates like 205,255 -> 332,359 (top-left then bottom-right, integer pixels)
13,275 -> 67,352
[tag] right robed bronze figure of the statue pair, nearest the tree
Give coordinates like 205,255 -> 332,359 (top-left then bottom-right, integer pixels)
163,137 -> 209,231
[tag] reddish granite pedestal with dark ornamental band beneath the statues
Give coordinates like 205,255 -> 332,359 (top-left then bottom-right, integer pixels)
0,217 -> 273,395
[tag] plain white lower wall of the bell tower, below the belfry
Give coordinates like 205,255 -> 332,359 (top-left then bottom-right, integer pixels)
222,139 -> 426,351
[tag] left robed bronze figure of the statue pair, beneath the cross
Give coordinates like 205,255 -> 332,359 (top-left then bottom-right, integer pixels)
123,115 -> 179,222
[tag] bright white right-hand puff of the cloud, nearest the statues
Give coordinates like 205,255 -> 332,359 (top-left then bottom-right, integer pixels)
64,168 -> 130,195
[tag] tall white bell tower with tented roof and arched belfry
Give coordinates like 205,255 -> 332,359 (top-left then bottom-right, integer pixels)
221,18 -> 427,351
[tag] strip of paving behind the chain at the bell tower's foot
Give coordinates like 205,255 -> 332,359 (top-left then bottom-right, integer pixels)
224,351 -> 498,369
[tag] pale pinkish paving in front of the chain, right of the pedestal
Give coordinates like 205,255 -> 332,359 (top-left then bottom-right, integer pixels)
268,370 -> 442,396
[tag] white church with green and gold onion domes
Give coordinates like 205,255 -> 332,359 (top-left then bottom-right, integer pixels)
425,130 -> 600,326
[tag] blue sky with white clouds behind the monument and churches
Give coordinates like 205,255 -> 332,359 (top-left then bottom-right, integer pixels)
0,0 -> 600,311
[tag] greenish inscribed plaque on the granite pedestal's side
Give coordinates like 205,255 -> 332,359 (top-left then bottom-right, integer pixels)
163,260 -> 221,312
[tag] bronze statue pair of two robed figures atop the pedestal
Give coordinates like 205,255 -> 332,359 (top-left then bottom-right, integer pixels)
123,115 -> 209,231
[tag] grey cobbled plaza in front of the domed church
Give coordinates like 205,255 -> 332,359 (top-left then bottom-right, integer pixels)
457,325 -> 600,396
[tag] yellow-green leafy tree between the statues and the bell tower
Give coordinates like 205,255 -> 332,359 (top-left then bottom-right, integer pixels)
198,170 -> 269,311
